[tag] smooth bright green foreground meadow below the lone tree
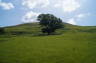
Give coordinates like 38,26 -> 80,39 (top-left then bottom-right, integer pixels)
0,33 -> 96,63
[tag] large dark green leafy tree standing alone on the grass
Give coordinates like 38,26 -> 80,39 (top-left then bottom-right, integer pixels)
37,14 -> 63,35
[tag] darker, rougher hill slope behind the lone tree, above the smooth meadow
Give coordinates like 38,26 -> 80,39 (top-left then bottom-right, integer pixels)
1,23 -> 96,35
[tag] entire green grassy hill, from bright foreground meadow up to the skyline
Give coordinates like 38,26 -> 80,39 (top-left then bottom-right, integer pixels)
0,23 -> 96,63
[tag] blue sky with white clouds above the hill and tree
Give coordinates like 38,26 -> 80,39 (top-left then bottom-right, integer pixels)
0,0 -> 96,27
